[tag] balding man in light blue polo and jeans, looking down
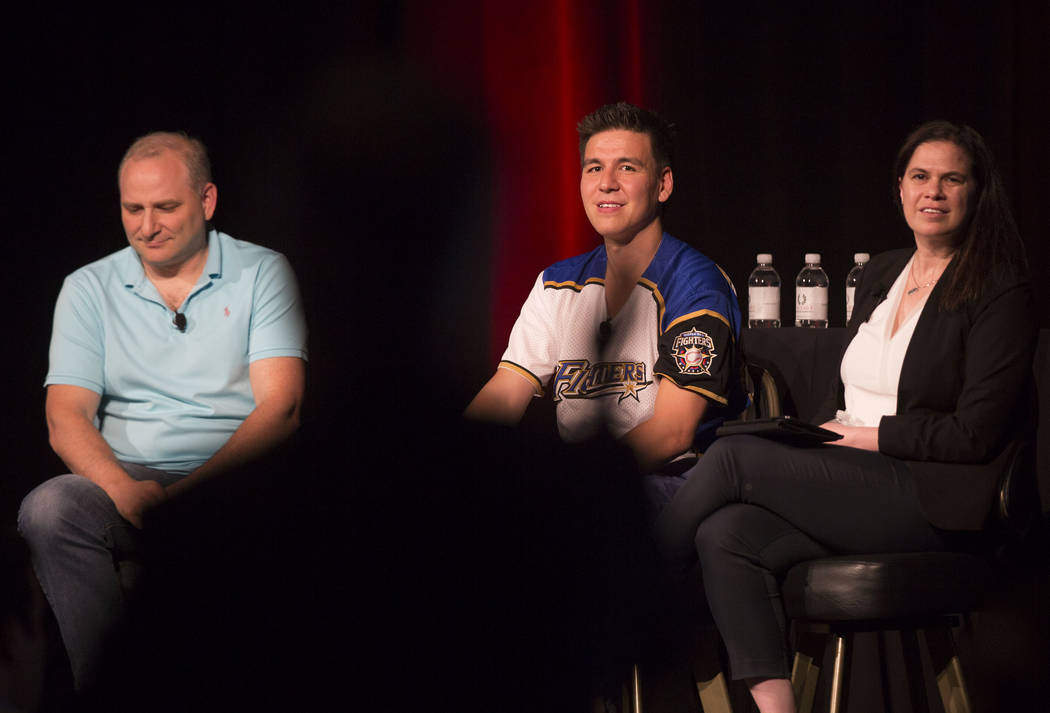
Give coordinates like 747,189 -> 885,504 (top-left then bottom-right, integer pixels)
19,132 -> 307,690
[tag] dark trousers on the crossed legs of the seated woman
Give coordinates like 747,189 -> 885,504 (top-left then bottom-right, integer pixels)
655,436 -> 945,678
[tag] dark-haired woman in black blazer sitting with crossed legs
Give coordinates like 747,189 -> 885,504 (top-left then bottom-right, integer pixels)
655,122 -> 1036,713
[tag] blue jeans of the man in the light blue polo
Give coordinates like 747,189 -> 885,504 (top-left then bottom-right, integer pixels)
18,463 -> 184,690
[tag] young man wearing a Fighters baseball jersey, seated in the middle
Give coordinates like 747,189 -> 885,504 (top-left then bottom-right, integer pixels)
465,102 -> 744,493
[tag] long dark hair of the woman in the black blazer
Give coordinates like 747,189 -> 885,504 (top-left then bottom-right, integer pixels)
894,121 -> 1028,310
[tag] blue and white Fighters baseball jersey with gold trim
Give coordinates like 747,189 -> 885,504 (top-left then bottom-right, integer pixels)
500,233 -> 744,442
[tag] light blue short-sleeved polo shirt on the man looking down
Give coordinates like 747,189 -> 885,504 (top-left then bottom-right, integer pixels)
44,230 -> 307,473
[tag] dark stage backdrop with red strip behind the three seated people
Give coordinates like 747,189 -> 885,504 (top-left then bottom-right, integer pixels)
0,0 -> 1050,709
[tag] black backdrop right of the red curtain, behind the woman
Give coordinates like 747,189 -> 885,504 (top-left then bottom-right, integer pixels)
656,1 -> 1050,327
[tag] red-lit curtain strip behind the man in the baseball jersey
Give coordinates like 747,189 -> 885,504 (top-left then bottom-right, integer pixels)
406,0 -> 652,368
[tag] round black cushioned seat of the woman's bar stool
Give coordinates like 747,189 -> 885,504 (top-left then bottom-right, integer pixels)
781,552 -> 992,622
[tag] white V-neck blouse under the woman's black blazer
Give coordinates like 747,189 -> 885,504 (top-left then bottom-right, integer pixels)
835,255 -> 929,426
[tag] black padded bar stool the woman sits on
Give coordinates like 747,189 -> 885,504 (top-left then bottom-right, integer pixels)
781,441 -> 1038,713
